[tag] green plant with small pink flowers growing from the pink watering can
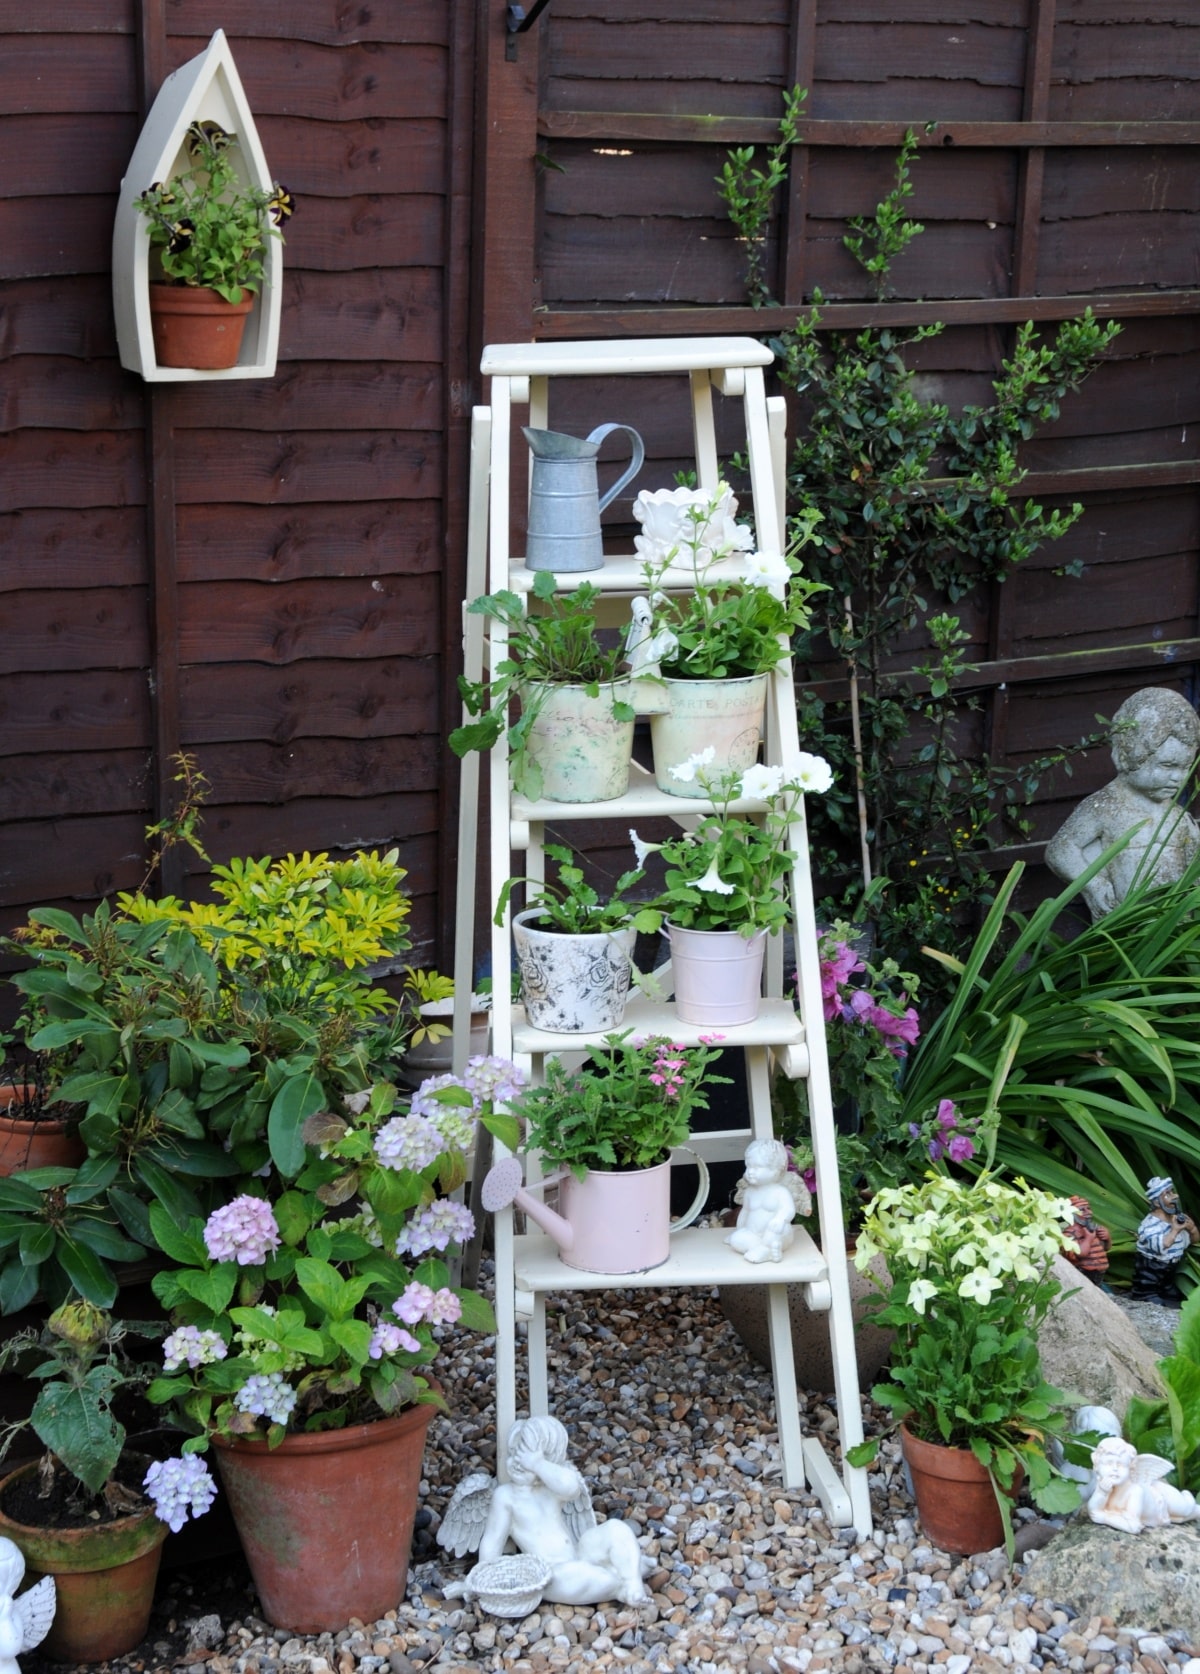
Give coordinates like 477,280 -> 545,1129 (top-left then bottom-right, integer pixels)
510,1030 -> 728,1178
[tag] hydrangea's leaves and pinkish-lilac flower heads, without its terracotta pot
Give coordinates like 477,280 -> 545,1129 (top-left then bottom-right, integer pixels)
147,1058 -> 522,1446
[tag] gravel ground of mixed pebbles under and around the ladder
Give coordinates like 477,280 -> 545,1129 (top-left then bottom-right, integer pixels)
22,1265 -> 1200,1674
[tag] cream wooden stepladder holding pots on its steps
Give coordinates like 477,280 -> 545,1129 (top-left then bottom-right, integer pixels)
455,336 -> 870,1537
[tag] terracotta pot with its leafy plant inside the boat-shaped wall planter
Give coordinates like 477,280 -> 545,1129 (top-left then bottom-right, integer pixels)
134,122 -> 295,372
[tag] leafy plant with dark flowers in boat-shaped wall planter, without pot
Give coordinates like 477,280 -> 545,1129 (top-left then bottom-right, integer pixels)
134,122 -> 295,303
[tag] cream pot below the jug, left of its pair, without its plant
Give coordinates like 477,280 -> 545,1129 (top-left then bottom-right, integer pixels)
526,681 -> 633,802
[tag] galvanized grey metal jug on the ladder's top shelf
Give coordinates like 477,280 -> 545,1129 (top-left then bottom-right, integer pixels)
522,424 -> 646,571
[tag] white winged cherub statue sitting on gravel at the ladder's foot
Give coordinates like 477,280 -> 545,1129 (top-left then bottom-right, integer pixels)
437,1418 -> 648,1610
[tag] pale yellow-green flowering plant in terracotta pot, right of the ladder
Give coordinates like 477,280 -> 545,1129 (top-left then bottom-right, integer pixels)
850,1173 -> 1088,1557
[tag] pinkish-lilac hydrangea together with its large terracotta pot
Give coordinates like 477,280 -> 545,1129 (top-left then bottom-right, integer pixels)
138,1058 -> 522,1632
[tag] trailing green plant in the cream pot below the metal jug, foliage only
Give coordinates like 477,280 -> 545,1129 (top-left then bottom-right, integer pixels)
450,571 -> 634,795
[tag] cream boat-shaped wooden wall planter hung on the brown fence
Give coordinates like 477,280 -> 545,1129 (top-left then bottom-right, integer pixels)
112,28 -> 283,383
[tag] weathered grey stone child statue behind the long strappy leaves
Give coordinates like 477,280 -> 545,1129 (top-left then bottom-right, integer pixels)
1046,686 -> 1200,919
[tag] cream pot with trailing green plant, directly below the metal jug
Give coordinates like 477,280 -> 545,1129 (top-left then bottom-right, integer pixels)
450,571 -> 634,802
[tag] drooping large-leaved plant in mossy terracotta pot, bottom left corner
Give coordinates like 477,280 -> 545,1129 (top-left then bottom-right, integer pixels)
0,1301 -> 216,1662
